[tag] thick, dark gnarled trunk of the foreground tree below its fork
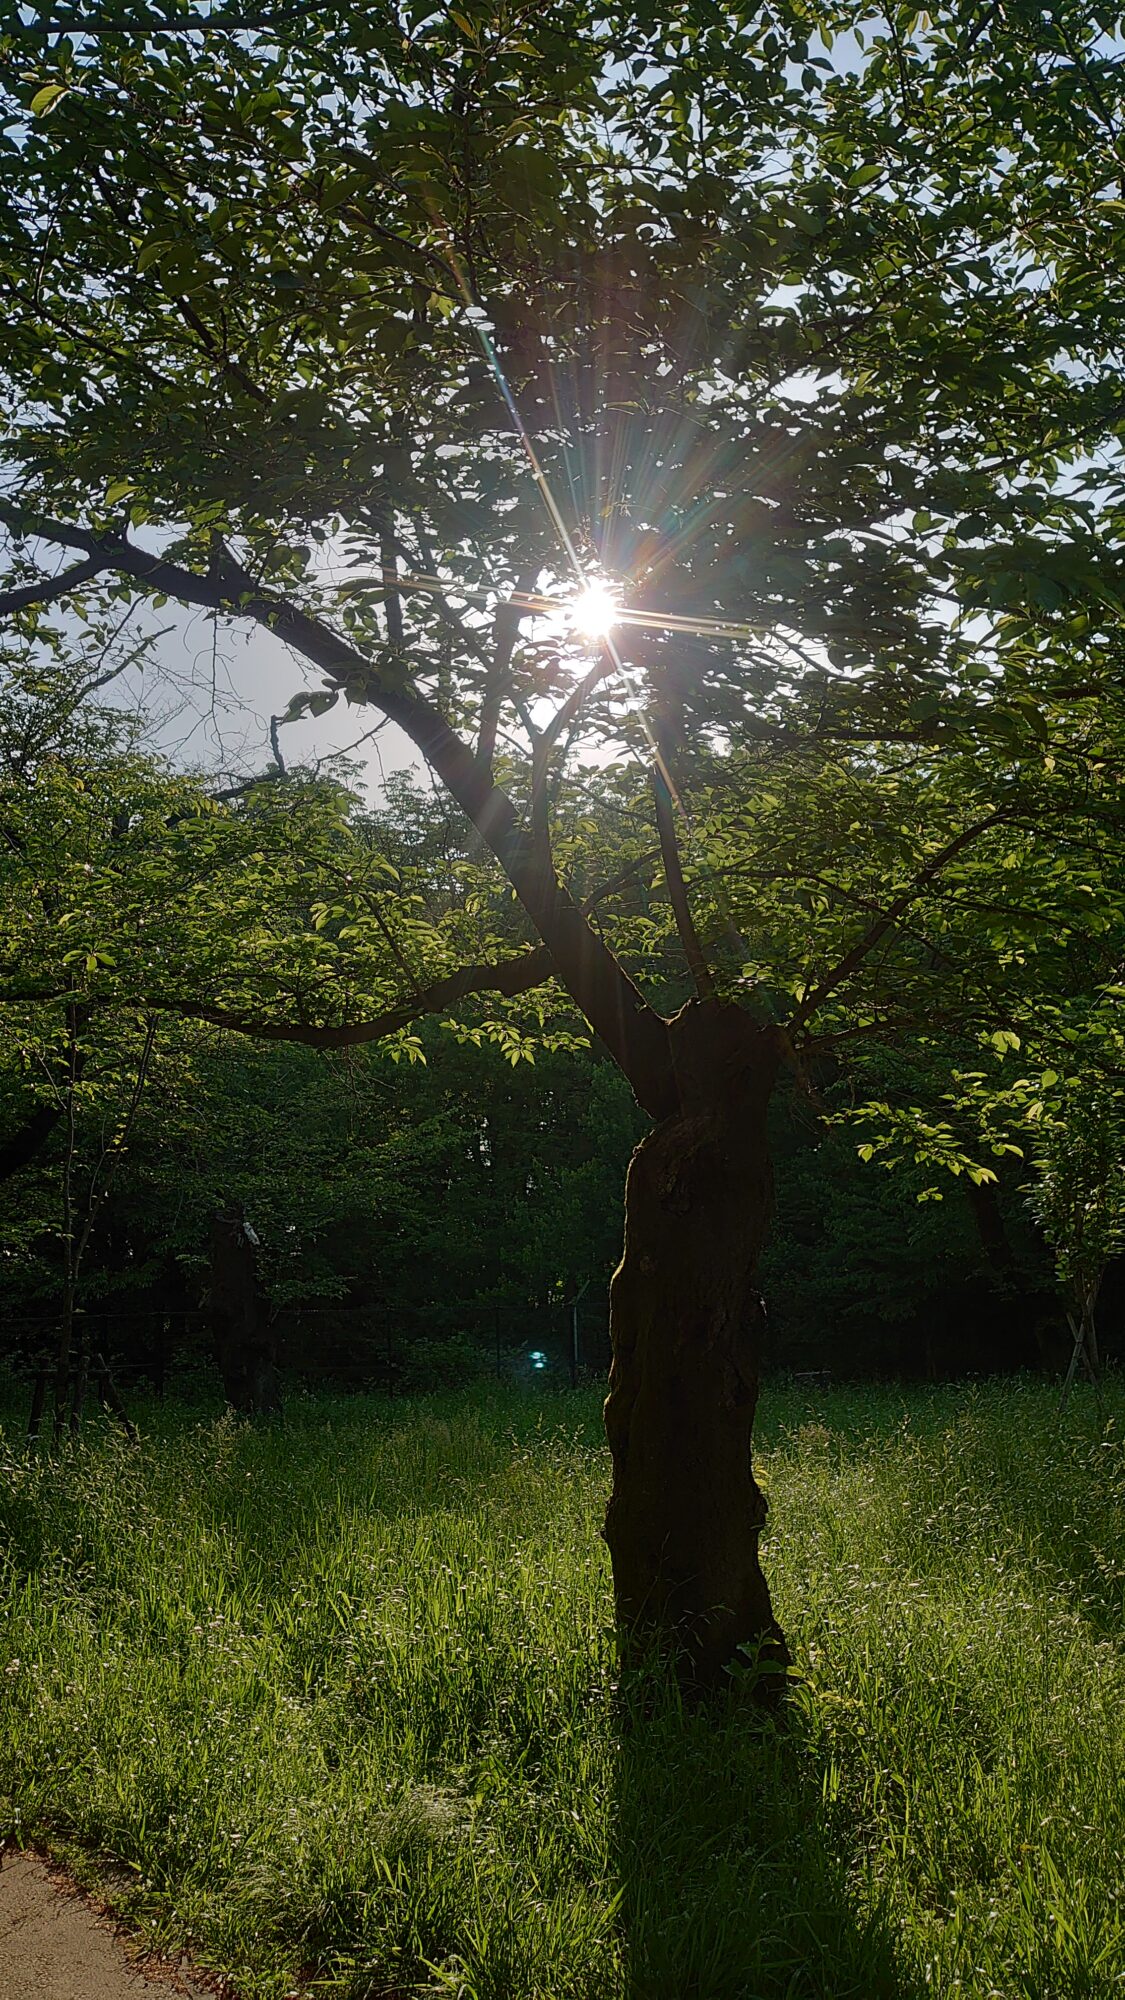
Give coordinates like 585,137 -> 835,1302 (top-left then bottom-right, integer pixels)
605,1002 -> 787,1692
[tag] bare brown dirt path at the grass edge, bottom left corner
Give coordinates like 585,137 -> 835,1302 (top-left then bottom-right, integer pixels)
0,1854 -> 214,2000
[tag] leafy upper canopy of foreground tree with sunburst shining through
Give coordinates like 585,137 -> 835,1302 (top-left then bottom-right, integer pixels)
2,8 -> 1121,1080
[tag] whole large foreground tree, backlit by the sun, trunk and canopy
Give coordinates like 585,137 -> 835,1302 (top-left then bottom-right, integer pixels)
0,0 -> 1123,1682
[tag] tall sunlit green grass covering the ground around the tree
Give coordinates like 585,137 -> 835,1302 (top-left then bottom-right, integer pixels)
0,1382 -> 1125,2000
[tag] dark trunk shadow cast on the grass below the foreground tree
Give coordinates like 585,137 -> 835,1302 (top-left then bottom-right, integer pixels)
617,1676 -> 911,2000
